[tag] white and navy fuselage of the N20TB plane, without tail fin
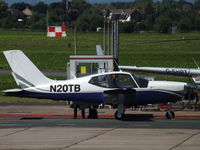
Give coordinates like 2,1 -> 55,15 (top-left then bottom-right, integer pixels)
3,72 -> 186,106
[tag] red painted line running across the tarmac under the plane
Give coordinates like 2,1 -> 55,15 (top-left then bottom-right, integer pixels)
0,114 -> 200,118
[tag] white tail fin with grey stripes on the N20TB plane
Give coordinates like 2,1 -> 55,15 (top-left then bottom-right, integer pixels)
3,50 -> 50,88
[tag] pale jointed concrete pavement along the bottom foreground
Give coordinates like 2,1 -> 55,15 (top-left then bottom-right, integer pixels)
0,127 -> 200,150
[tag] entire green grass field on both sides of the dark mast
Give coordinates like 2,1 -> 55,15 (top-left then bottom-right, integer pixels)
0,30 -> 200,101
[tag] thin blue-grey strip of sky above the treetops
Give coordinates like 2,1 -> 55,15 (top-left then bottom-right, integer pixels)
4,0 -> 195,5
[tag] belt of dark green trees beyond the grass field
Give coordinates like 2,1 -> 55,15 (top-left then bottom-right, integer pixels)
0,0 -> 200,33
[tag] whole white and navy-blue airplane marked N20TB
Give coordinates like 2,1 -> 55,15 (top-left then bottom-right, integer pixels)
3,50 -> 191,119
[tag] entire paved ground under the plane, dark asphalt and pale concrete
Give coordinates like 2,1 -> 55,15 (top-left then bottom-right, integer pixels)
0,105 -> 200,150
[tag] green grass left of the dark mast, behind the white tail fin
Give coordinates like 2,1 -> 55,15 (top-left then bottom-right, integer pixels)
0,31 -> 102,70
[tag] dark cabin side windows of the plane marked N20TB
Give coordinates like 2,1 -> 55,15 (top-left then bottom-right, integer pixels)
89,74 -> 137,88
